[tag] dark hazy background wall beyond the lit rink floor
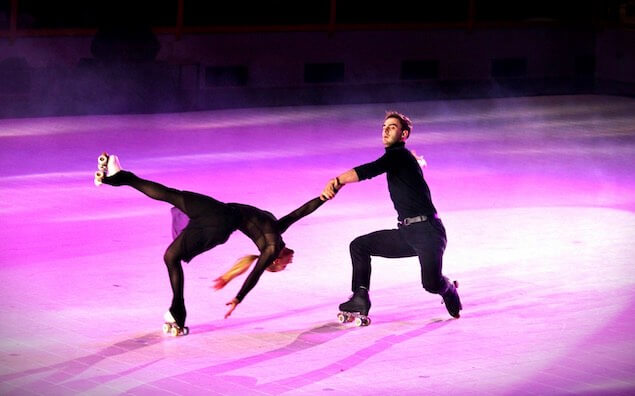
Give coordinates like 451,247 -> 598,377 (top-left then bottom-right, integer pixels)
0,0 -> 635,118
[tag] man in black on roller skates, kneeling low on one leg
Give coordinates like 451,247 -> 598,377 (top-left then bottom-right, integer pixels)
322,112 -> 463,318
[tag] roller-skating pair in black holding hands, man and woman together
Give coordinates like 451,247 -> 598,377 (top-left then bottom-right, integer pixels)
95,112 -> 462,335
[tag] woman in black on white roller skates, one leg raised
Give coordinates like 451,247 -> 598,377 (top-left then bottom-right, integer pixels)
95,153 -> 327,335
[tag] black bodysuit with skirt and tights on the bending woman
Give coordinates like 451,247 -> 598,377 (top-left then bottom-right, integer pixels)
103,170 -> 324,327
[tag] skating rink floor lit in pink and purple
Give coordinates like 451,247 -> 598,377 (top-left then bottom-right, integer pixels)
0,96 -> 635,395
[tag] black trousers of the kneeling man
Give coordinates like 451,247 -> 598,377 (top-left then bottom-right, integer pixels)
350,218 -> 448,294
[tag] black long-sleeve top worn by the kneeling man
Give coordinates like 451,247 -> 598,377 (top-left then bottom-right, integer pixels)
353,142 -> 437,221
